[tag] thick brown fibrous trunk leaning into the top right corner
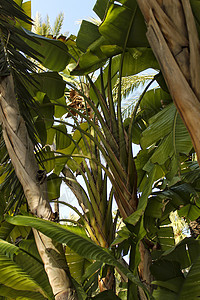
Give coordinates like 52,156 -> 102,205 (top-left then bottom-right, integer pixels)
137,0 -> 200,165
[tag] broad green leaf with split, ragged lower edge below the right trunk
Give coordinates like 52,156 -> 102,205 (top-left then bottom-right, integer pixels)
140,104 -> 192,179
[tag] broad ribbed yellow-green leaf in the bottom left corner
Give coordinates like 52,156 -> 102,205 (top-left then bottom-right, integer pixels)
0,240 -> 52,299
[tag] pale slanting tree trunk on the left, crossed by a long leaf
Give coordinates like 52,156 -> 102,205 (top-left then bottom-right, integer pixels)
0,75 -> 77,300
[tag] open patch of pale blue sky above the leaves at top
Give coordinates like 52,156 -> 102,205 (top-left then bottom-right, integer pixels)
31,0 -> 96,35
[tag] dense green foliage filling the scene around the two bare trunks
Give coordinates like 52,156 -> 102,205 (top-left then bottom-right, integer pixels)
0,0 -> 200,300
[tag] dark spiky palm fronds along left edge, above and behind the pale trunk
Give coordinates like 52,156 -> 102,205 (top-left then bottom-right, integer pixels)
0,0 -> 44,213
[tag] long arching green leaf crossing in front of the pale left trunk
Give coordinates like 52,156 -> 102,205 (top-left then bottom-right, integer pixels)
6,216 -> 150,297
